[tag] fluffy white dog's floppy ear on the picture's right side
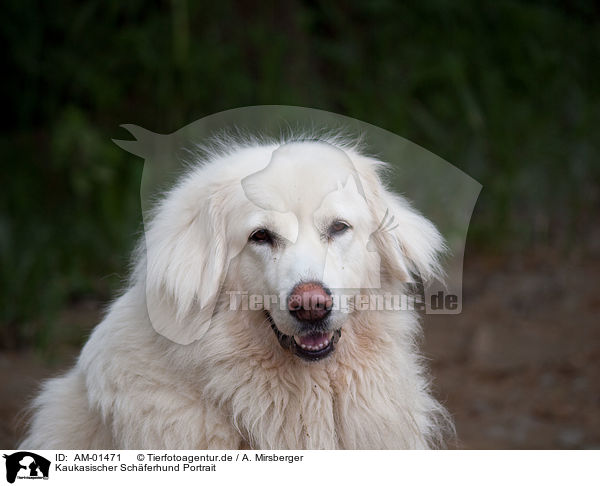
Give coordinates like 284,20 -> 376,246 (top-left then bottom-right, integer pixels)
357,158 -> 446,284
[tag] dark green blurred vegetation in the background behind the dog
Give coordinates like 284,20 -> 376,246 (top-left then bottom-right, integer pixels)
0,0 -> 600,349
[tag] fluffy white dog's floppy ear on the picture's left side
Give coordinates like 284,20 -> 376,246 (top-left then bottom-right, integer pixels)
138,179 -> 230,344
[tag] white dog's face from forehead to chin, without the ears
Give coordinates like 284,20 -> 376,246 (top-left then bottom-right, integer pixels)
239,143 -> 379,360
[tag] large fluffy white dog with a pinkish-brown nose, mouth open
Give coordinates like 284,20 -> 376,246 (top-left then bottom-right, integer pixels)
20,138 -> 451,449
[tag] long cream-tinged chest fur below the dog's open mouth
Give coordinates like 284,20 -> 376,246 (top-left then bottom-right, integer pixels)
196,314 -> 436,449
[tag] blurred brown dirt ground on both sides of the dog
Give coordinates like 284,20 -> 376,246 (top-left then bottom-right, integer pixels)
0,254 -> 600,449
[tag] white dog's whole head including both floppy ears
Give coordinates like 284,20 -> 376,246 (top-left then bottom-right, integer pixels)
146,142 -> 442,361
